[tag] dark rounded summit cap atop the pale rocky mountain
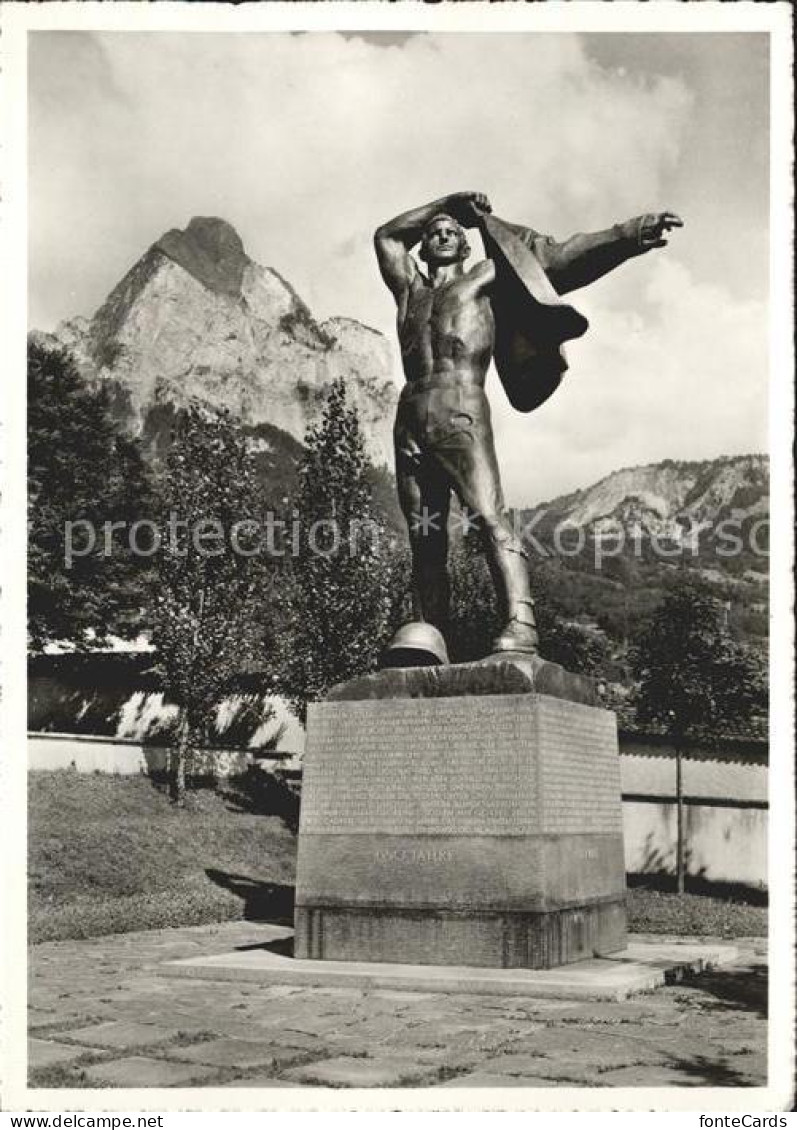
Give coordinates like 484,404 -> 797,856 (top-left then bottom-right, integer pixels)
155,216 -> 250,298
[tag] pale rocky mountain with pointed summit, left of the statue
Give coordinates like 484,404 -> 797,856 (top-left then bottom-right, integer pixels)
35,216 -> 398,464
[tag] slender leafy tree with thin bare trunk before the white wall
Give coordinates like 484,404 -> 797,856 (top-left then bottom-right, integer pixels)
151,409 -> 270,806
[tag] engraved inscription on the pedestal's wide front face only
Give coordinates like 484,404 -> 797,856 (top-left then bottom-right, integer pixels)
302,695 -> 536,835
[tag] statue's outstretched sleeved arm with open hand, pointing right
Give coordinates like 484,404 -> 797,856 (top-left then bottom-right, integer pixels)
508,212 -> 683,294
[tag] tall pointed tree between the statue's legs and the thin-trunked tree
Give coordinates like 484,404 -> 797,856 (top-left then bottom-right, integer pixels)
277,380 -> 406,720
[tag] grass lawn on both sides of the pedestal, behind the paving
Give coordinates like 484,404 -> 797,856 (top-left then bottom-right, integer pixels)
28,770 -> 766,942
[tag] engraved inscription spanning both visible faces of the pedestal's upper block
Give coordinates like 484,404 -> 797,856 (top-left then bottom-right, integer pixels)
302,695 -> 622,840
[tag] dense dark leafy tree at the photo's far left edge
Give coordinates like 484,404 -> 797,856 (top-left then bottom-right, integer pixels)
27,340 -> 155,650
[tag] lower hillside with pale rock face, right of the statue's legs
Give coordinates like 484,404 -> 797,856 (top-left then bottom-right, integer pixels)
518,454 -> 769,647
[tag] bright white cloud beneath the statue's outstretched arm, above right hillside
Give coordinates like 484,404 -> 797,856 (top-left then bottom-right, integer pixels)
493,251 -> 769,505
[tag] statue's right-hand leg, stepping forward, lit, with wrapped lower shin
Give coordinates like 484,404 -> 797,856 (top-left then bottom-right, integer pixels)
434,389 -> 537,652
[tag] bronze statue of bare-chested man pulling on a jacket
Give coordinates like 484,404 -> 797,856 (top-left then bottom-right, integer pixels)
374,192 -> 683,661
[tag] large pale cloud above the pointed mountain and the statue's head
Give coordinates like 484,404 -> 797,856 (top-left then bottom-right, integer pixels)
32,33 -> 688,324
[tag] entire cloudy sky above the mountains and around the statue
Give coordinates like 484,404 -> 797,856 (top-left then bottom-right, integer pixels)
28,32 -> 769,504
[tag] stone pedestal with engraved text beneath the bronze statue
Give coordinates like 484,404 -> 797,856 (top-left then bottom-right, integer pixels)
295,657 -> 626,970
